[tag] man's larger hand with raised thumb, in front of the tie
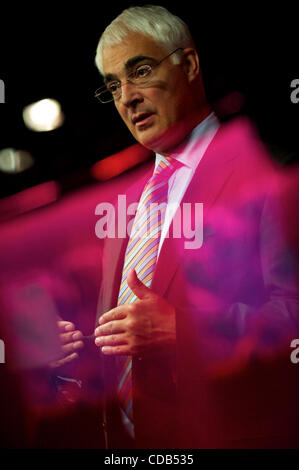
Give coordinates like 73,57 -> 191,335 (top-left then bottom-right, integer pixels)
95,270 -> 176,356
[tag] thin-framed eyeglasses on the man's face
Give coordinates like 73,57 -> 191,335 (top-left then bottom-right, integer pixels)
95,47 -> 183,103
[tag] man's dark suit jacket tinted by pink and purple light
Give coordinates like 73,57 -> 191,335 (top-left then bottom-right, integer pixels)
98,119 -> 299,448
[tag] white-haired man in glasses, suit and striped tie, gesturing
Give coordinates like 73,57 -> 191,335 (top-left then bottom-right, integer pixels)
56,6 -> 298,448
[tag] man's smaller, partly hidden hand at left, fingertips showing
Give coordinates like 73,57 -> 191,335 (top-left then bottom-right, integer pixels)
50,320 -> 84,368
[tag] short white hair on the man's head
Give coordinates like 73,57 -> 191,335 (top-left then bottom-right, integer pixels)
95,5 -> 194,75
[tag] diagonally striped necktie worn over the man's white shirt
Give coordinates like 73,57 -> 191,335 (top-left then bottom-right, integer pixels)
117,157 -> 178,432
